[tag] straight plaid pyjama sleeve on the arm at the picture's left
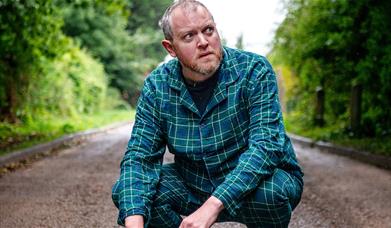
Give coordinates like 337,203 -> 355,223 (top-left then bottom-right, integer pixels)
118,81 -> 165,225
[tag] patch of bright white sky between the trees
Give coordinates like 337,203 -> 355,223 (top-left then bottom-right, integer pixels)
200,0 -> 285,55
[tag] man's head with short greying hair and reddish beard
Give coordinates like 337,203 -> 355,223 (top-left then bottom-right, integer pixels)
160,0 -> 222,81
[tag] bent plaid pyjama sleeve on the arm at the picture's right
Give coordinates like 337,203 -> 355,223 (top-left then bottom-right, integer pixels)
213,60 -> 284,216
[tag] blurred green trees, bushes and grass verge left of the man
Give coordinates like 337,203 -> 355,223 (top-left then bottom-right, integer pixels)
0,0 -> 171,154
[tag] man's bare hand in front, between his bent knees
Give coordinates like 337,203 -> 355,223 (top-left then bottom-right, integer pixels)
179,196 -> 224,228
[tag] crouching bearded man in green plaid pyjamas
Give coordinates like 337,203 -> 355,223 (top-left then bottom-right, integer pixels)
113,0 -> 303,228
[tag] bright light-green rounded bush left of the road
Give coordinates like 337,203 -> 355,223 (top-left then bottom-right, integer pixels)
23,42 -> 107,119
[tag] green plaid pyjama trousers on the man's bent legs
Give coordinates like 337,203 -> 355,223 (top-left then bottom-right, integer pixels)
112,164 -> 303,228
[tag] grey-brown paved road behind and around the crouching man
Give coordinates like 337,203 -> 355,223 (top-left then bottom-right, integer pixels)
0,126 -> 391,228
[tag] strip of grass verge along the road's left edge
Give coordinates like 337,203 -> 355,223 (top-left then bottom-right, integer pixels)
0,109 -> 135,156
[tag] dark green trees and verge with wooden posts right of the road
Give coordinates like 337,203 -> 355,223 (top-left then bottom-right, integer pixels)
268,0 -> 391,156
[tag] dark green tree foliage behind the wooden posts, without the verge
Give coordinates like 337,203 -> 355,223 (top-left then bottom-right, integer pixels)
271,0 -> 391,136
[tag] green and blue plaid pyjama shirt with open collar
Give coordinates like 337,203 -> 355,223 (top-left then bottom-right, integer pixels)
119,47 -> 302,223
